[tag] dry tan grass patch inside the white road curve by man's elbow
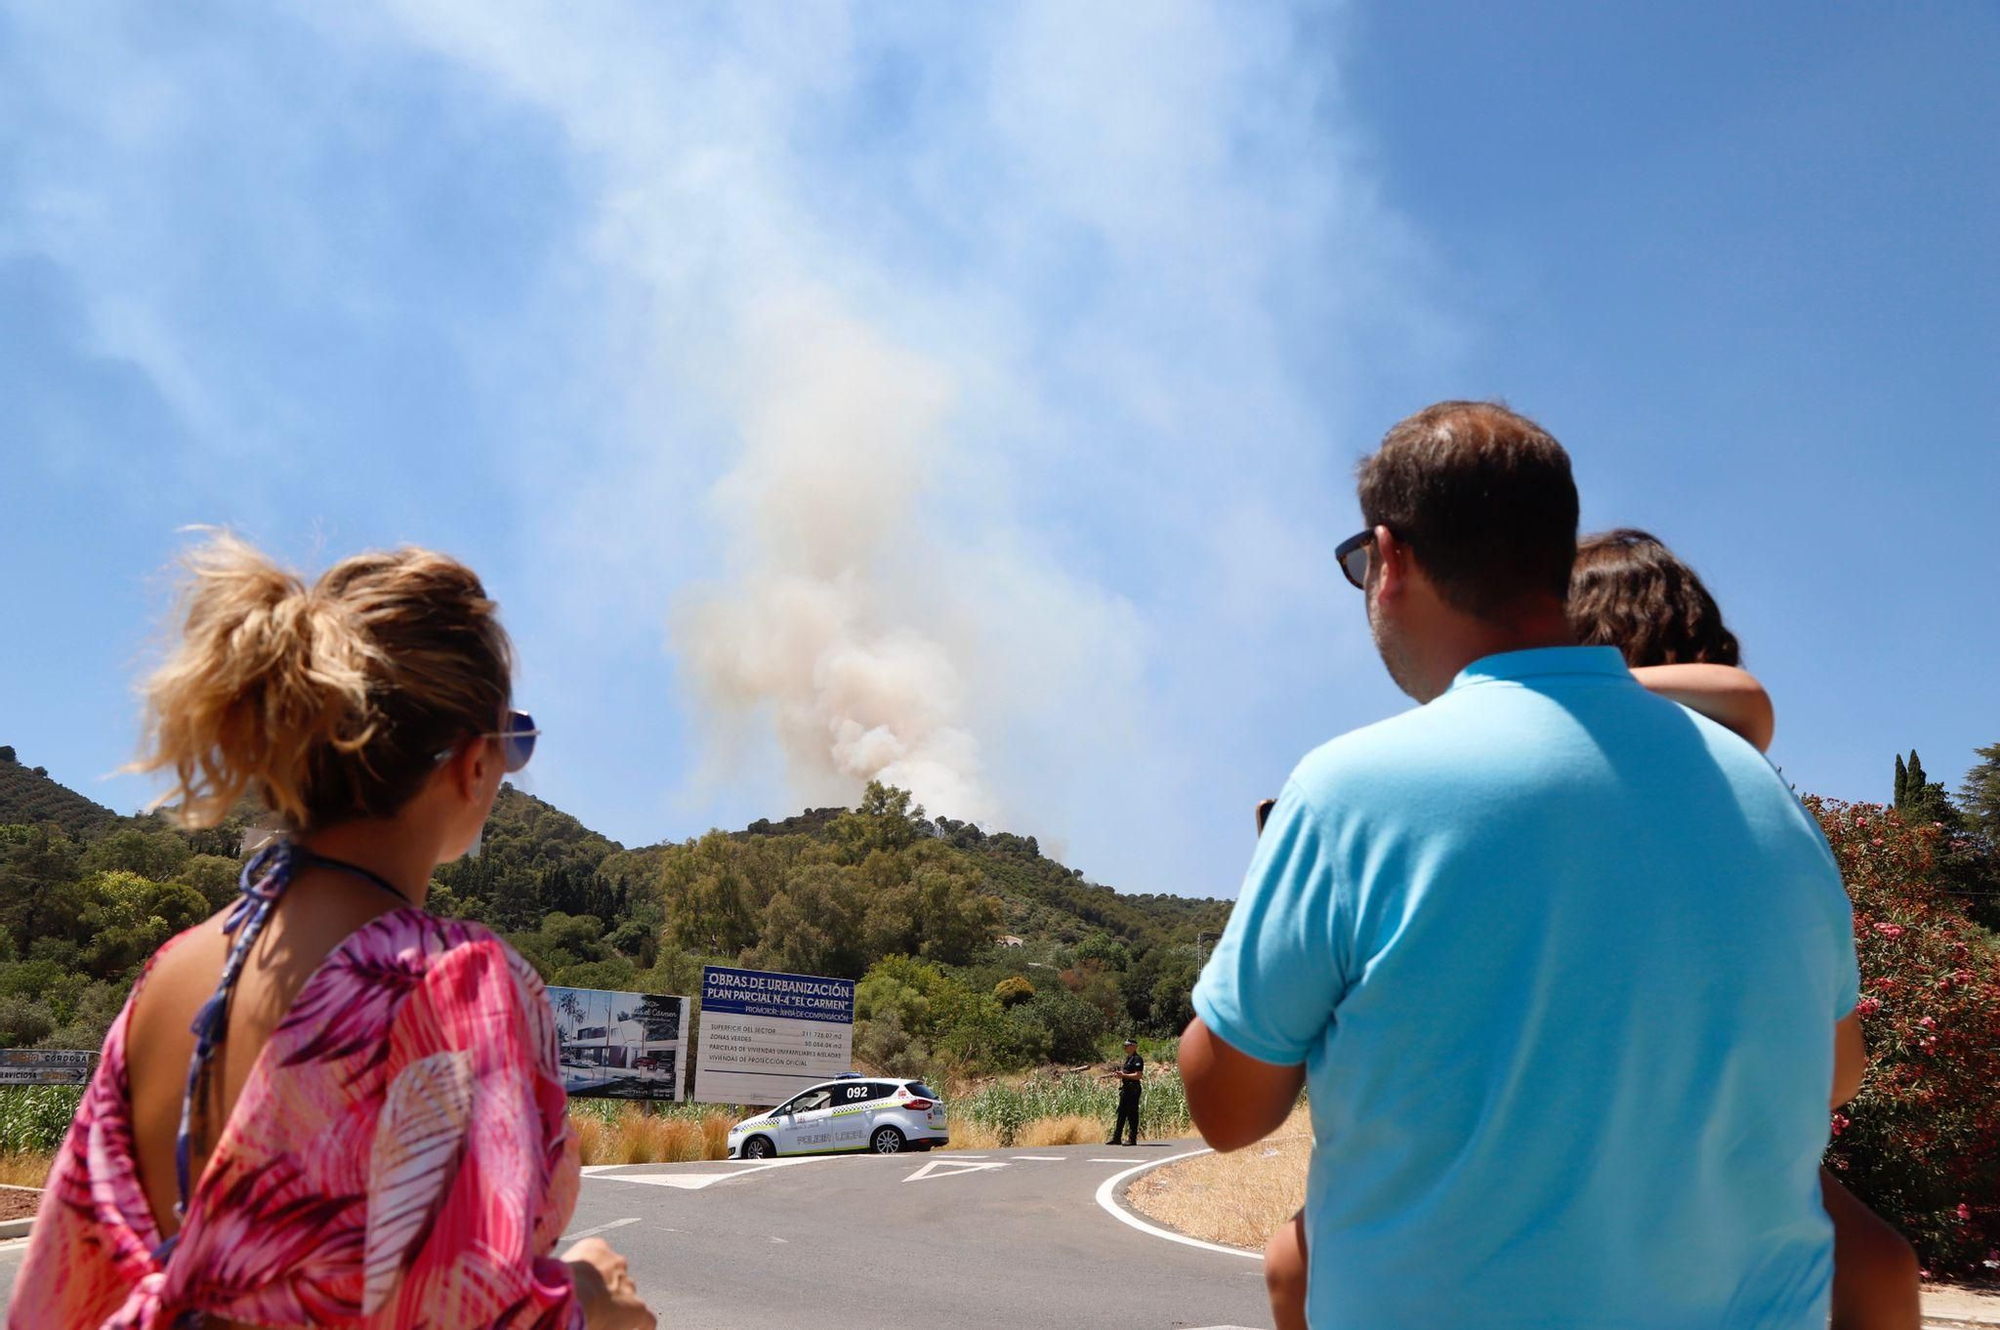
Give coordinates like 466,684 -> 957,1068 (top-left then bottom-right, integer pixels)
1128,1108 -> 1312,1250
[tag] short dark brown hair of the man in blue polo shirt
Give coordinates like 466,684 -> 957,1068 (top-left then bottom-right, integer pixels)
1360,402 -> 1576,620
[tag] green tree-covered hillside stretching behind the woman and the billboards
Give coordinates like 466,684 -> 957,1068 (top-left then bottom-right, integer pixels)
0,750 -> 1230,1062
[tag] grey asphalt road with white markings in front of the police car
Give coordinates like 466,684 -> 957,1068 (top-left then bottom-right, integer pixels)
0,1142 -> 1270,1330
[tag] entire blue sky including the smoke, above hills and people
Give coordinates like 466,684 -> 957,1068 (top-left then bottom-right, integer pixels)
0,0 -> 2000,894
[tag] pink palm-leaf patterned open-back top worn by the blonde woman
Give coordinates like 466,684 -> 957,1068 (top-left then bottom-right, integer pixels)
8,910 -> 584,1330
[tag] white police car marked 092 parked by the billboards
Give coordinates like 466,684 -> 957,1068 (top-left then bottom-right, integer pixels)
730,1074 -> 950,1160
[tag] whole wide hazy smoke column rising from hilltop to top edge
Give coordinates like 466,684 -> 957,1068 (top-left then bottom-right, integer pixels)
348,0 -> 1440,892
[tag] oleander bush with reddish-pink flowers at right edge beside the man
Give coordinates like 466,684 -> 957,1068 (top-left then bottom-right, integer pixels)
1806,796 -> 2000,1278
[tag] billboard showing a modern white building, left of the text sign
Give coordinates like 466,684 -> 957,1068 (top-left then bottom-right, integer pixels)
548,988 -> 688,1100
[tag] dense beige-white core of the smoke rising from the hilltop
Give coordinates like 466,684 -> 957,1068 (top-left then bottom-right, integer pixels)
674,298 -> 996,820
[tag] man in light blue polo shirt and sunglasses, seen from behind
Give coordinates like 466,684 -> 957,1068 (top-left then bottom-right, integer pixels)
1180,402 -> 1860,1330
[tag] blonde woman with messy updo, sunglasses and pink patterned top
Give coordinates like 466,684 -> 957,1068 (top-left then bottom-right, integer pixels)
8,536 -> 654,1330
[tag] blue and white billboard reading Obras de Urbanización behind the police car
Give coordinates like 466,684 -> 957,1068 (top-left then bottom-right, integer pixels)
694,966 -> 854,1106
